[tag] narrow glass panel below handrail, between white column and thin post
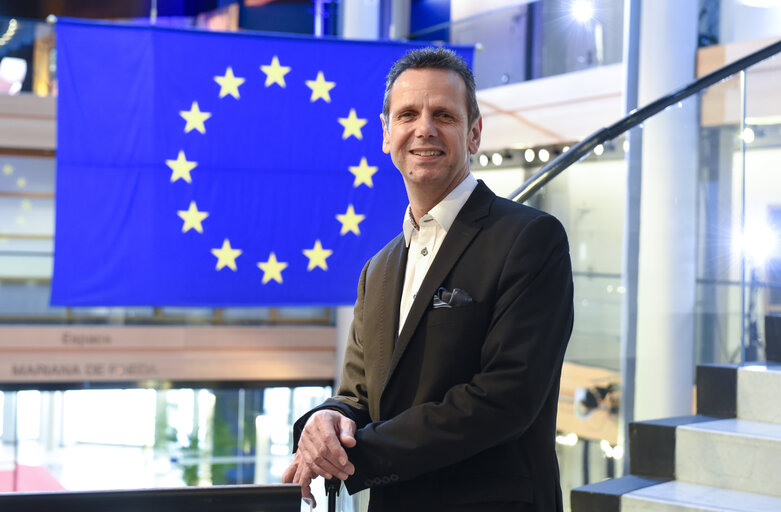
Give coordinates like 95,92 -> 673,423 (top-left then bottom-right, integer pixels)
695,72 -> 743,364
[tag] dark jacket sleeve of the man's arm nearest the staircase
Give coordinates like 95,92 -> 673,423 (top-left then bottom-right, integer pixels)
343,215 -> 573,493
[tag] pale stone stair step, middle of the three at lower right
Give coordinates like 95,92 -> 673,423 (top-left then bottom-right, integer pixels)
675,419 -> 781,496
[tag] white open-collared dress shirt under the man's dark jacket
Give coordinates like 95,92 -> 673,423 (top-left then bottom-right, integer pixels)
399,173 -> 477,333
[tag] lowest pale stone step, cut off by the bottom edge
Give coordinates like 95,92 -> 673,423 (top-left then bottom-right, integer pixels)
621,481 -> 781,512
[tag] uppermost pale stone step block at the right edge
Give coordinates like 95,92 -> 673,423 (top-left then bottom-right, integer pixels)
737,363 -> 781,425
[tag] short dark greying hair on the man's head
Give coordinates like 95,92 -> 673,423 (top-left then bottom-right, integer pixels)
382,46 -> 480,126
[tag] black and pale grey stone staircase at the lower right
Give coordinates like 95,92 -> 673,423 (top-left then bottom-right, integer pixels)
571,363 -> 781,512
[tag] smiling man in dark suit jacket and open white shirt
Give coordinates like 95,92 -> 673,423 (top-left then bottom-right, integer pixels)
283,48 -> 572,512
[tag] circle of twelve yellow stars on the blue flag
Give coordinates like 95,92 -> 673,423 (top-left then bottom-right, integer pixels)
165,55 -> 378,285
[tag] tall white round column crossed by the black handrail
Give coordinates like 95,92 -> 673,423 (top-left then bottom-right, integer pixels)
634,0 -> 698,420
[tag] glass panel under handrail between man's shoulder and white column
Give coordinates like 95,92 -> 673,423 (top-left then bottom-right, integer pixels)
532,140 -> 626,372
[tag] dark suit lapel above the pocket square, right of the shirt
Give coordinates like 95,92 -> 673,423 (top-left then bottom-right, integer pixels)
383,181 -> 496,392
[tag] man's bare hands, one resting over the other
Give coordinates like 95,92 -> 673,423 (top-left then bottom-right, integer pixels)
282,409 -> 355,502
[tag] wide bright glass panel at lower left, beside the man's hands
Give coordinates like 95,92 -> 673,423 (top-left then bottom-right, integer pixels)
0,386 -> 331,494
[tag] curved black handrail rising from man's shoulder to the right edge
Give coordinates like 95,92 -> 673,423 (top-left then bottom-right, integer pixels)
508,37 -> 781,203
